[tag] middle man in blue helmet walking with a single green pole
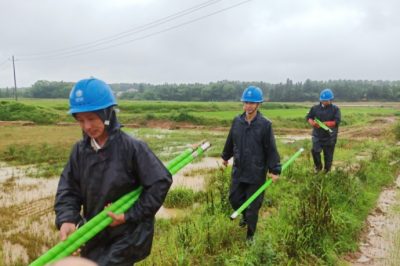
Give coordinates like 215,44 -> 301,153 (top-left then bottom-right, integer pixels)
221,86 -> 281,242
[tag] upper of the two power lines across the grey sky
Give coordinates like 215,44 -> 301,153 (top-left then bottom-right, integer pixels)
19,0 -> 222,60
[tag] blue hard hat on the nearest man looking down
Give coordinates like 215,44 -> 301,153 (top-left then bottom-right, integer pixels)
68,78 -> 117,114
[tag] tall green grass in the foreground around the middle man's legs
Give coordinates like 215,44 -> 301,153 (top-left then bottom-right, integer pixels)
139,140 -> 395,265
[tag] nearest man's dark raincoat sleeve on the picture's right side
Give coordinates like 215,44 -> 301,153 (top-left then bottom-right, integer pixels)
125,141 -> 172,223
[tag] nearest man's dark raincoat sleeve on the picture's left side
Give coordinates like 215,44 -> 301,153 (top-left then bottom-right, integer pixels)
54,144 -> 82,229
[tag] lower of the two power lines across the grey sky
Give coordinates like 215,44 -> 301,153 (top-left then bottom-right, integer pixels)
21,0 -> 252,61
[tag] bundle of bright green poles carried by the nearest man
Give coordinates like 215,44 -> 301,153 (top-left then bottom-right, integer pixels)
30,142 -> 210,266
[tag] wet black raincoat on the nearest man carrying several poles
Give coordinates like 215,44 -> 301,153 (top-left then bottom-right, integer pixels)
55,120 -> 172,265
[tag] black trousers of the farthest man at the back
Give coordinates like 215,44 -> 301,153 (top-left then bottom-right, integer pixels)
311,139 -> 336,172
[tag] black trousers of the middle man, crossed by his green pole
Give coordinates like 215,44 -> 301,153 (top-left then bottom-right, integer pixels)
229,182 -> 264,237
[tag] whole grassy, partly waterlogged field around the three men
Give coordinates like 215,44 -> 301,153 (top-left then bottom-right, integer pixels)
0,100 -> 400,265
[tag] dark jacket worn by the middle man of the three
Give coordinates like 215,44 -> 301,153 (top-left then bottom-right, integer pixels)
221,112 -> 281,184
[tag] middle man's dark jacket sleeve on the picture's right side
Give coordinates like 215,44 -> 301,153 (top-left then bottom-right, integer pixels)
264,124 -> 281,175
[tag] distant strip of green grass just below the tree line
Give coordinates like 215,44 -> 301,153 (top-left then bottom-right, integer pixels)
0,99 -> 399,128
